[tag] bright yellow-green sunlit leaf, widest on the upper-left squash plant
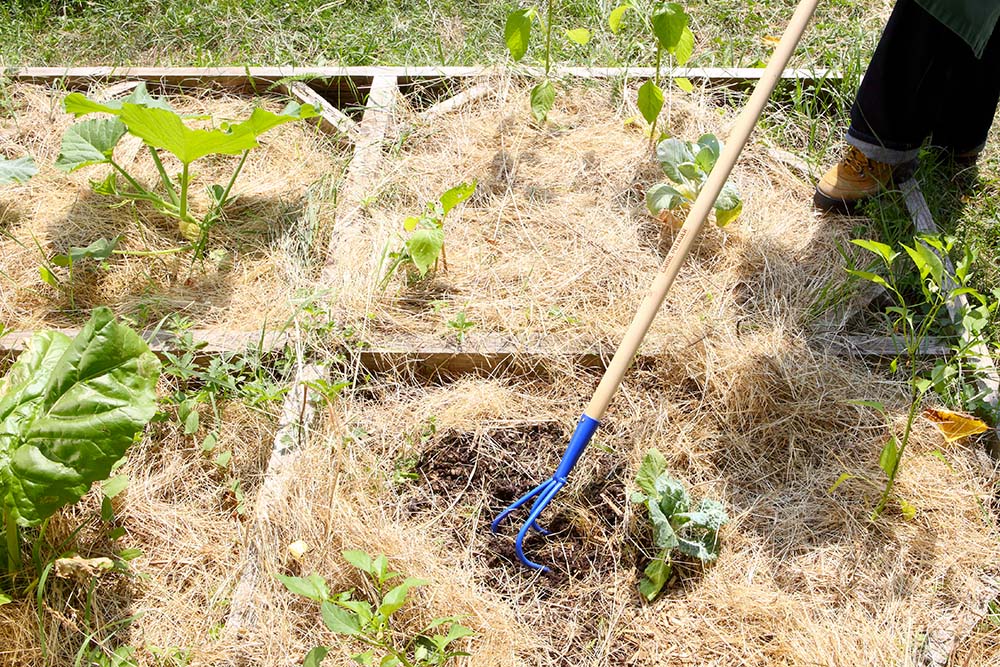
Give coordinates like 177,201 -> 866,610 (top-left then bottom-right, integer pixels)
118,103 -> 316,164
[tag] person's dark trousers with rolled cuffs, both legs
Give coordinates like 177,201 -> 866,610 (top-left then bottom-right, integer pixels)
847,0 -> 1000,163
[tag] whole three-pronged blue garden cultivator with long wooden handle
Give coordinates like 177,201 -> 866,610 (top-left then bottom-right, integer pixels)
490,0 -> 819,571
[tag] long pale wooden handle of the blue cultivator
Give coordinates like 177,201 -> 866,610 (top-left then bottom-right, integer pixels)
584,0 -> 819,421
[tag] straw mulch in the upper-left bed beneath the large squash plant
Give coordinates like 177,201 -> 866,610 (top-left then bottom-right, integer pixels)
0,85 -> 347,330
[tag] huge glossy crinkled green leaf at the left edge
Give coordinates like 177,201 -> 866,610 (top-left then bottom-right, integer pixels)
0,308 -> 160,526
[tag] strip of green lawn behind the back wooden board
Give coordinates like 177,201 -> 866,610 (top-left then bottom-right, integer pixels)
0,0 -> 884,68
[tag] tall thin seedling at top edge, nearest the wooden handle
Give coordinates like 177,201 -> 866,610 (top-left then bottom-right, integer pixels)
608,2 -> 694,141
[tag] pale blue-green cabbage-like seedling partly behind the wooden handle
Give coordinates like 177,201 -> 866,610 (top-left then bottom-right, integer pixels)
646,134 -> 743,227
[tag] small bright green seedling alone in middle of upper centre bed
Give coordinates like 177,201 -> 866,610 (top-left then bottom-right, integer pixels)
381,181 -> 476,289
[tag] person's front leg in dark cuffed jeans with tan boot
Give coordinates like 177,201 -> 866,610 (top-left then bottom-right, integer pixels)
813,0 -> 971,211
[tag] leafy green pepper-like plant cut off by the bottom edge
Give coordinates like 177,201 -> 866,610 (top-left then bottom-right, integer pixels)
277,551 -> 475,667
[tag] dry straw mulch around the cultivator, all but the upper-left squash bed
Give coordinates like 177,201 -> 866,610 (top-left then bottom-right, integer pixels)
0,82 -> 1000,667
